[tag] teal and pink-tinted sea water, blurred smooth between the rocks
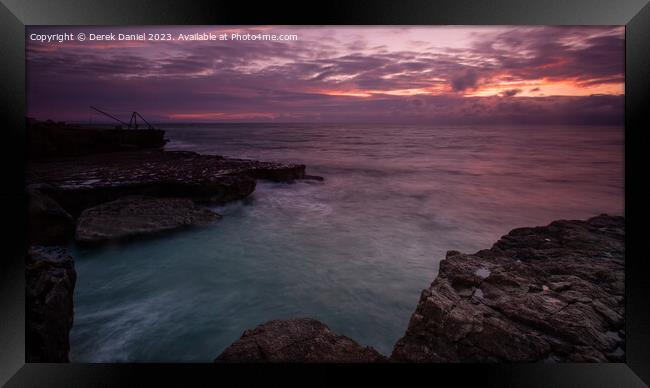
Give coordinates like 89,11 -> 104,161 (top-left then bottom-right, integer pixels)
71,124 -> 624,362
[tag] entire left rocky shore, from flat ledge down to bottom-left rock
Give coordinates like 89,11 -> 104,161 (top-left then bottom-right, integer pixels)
25,149 -> 323,362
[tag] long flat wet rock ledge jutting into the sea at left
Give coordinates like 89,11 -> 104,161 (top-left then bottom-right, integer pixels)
26,150 -> 305,217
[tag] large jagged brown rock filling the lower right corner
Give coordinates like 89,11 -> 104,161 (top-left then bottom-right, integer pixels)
391,215 -> 625,362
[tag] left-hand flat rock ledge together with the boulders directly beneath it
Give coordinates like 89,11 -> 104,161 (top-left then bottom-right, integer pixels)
26,150 -> 310,244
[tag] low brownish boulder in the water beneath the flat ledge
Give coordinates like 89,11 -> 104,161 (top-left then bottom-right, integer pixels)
75,196 -> 221,243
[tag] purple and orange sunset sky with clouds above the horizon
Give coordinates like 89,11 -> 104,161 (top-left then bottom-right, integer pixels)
26,26 -> 625,125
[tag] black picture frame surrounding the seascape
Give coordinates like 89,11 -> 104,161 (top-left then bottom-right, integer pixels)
0,0 -> 650,387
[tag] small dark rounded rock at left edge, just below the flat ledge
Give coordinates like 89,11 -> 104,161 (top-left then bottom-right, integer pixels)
27,187 -> 74,245
